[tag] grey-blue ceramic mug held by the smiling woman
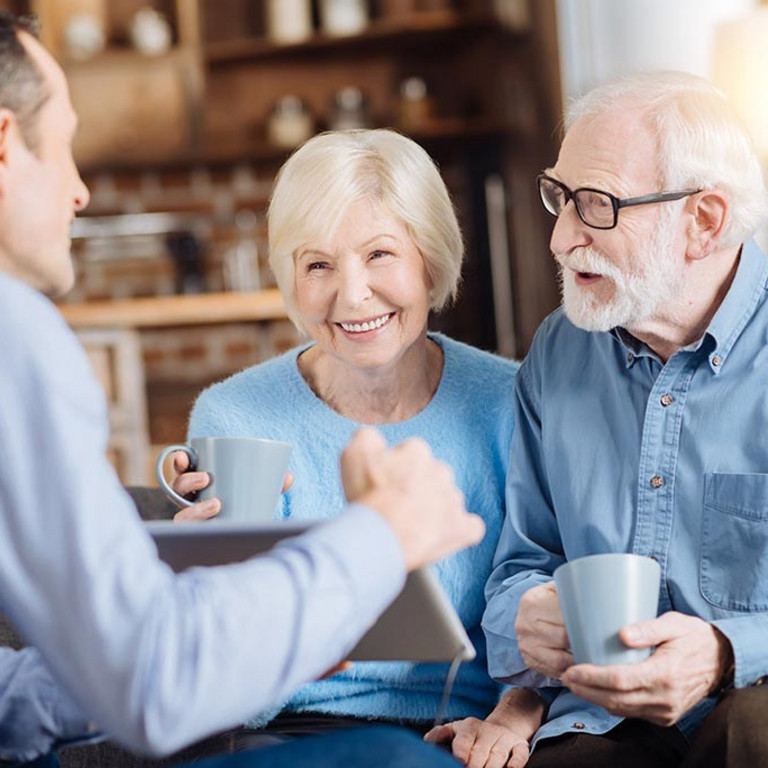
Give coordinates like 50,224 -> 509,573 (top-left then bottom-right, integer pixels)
155,437 -> 291,522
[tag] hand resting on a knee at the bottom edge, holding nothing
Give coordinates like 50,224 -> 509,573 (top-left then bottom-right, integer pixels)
424,717 -> 530,768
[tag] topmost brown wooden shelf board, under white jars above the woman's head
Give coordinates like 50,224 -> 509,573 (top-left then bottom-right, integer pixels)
204,11 -> 523,66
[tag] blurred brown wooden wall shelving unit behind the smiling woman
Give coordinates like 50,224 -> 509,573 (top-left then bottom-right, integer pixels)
6,0 -> 559,355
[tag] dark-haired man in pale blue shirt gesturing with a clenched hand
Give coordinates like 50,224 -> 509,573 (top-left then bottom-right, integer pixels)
0,13 -> 483,767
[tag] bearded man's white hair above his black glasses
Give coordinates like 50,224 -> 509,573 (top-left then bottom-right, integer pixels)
565,72 -> 768,247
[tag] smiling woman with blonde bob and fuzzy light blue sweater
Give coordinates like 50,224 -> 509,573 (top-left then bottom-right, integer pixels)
176,130 -> 540,762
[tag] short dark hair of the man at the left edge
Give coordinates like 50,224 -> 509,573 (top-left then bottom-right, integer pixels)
0,11 -> 50,150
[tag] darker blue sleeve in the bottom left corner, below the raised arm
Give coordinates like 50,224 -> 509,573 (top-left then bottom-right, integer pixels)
0,648 -> 96,762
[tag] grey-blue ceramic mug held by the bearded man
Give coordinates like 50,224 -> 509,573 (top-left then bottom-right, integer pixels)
555,553 -> 661,665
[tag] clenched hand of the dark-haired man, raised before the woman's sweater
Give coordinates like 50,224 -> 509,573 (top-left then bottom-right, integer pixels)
341,428 -> 485,570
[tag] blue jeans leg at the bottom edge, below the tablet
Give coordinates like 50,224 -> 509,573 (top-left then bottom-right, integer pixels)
179,725 -> 458,768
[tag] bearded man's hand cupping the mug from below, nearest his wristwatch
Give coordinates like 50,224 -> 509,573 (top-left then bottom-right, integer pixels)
562,612 -> 733,726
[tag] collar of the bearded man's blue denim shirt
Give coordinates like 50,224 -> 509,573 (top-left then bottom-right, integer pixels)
611,240 -> 768,374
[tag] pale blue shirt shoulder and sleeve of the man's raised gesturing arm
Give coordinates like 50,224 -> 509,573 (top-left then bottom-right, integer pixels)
0,273 -> 405,757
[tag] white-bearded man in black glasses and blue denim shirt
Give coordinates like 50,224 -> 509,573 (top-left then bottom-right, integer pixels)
483,73 -> 768,768
